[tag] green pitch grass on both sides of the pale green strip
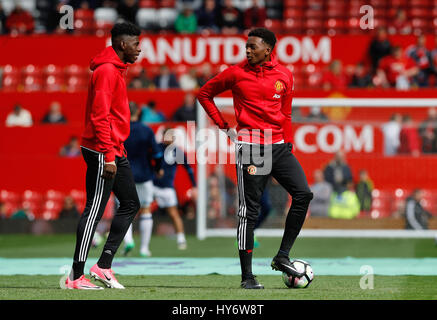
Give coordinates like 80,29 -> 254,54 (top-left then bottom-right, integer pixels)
0,234 -> 437,300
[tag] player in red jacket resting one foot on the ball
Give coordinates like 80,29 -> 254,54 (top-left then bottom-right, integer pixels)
198,28 -> 313,289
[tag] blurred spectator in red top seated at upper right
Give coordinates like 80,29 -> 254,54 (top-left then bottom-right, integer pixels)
378,46 -> 419,90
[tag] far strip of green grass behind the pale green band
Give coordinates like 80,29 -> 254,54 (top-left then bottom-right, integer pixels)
0,234 -> 437,258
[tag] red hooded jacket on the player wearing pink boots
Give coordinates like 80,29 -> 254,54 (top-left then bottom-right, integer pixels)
82,47 -> 130,162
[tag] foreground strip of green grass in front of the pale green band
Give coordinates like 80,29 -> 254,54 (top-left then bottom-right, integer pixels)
0,275 -> 437,300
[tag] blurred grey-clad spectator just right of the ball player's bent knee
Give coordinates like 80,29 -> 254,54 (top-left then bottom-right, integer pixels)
310,169 -> 332,217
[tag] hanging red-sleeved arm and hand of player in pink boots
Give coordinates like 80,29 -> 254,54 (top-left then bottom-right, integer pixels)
90,64 -> 117,179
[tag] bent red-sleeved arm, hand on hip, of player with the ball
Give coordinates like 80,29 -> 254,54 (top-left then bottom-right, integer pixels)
197,67 -> 235,130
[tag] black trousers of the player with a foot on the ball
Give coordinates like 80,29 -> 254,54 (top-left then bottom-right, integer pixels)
235,143 -> 312,250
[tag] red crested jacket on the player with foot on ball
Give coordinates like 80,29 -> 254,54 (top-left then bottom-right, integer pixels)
197,55 -> 294,144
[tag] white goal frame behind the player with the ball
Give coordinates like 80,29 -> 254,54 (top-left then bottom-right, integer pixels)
196,97 -> 437,239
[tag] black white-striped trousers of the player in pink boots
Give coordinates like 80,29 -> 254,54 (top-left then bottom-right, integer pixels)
74,147 -> 140,262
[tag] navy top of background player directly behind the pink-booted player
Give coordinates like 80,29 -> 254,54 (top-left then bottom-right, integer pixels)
124,121 -> 163,183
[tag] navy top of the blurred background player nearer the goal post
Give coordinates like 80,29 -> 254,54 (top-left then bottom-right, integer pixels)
153,143 -> 196,188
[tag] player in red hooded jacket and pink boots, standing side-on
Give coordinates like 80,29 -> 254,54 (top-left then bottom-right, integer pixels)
65,23 -> 141,290
